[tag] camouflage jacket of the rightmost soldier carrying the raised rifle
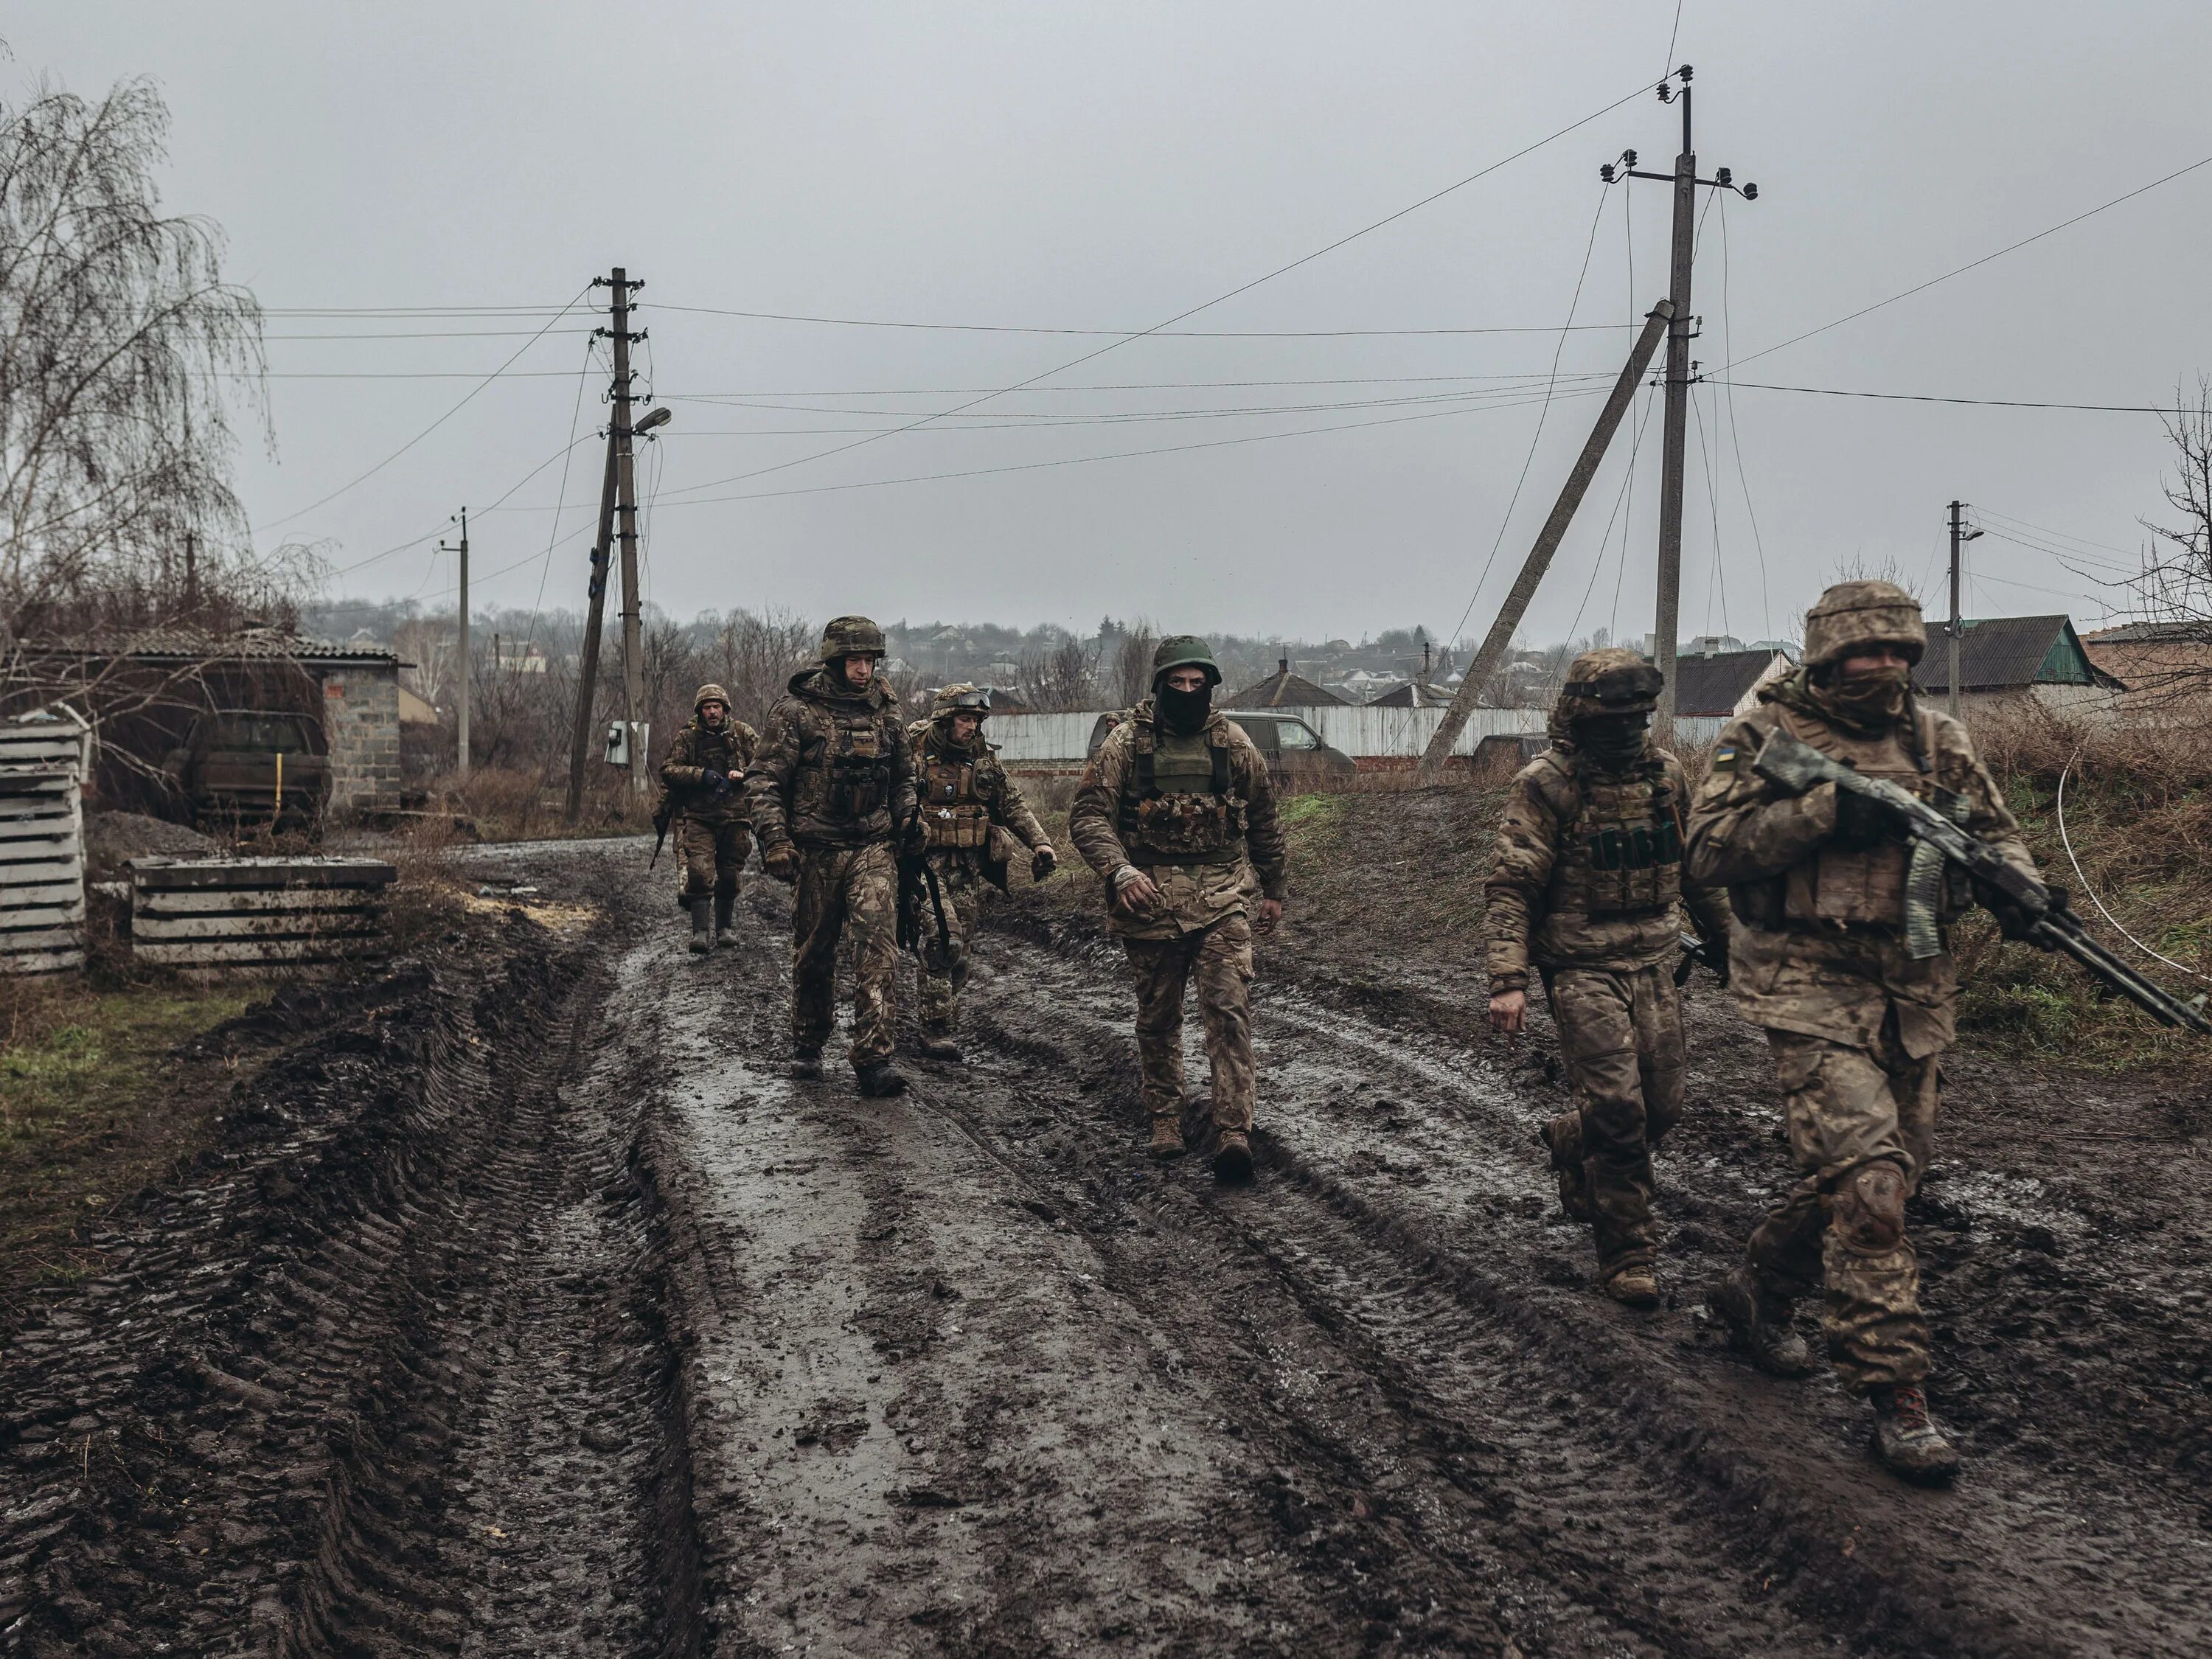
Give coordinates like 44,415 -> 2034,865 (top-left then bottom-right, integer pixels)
1690,677 -> 2035,1060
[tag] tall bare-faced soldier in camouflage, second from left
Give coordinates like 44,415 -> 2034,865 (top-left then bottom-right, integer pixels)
748,617 -> 920,1095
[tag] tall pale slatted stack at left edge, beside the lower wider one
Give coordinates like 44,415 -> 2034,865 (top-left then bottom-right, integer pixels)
0,761 -> 84,973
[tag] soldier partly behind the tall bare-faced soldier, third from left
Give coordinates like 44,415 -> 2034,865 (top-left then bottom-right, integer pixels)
907,686 -> 1060,1060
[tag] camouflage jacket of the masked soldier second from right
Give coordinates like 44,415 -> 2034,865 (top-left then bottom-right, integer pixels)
1486,734 -> 1728,995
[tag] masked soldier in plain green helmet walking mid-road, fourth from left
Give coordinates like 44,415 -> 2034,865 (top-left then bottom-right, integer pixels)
1068,635 -> 1285,1181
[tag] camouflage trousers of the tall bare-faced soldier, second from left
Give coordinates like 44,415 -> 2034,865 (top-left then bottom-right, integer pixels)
792,841 -> 898,1066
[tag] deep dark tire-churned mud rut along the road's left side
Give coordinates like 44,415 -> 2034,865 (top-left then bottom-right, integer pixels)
0,914 -> 699,1655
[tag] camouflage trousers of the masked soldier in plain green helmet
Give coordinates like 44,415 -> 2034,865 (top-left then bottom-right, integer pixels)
1121,911 -> 1254,1130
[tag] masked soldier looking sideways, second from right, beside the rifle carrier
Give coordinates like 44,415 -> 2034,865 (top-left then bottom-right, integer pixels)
1489,650 -> 1728,1307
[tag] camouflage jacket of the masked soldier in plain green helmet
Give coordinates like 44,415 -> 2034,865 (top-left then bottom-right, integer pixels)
1068,699 -> 1287,938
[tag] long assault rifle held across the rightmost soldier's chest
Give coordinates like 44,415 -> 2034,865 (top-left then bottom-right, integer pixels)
1752,730 -> 2212,1037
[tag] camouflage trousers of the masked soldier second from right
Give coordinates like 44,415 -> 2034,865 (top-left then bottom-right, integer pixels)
1544,964 -> 1683,1276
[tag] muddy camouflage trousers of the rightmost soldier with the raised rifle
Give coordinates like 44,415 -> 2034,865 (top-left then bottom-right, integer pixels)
1745,1015 -> 1938,1389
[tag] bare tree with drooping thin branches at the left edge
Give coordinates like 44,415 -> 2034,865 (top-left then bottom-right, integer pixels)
0,80 -> 276,639
